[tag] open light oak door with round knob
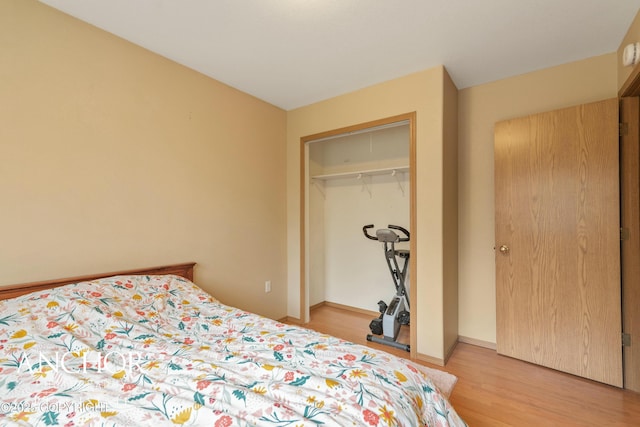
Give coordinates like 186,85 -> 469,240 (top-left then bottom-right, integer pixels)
495,99 -> 622,387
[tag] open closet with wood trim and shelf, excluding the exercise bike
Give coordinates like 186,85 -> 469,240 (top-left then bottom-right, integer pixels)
300,113 -> 417,356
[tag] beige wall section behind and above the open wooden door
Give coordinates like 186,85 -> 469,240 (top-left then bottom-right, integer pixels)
458,53 -> 617,343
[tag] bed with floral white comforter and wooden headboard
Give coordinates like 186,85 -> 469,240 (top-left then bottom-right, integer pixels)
0,263 -> 465,427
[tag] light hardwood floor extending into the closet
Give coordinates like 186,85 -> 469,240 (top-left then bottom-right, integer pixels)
305,306 -> 640,427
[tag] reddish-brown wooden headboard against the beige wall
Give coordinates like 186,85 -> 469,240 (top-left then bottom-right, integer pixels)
0,262 -> 196,300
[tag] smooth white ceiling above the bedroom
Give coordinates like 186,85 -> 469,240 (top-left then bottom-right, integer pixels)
40,0 -> 640,110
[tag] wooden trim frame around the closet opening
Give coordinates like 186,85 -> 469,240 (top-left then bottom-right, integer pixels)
300,111 -> 418,357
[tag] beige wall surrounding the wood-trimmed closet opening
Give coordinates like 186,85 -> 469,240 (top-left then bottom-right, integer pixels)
287,67 -> 458,359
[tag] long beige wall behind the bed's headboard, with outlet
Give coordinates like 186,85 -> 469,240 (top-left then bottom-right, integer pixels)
0,0 -> 287,318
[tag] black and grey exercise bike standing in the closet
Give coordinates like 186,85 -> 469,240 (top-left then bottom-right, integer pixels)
362,224 -> 410,351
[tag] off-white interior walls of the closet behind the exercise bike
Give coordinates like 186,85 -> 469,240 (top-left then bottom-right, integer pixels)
307,123 -> 413,312
